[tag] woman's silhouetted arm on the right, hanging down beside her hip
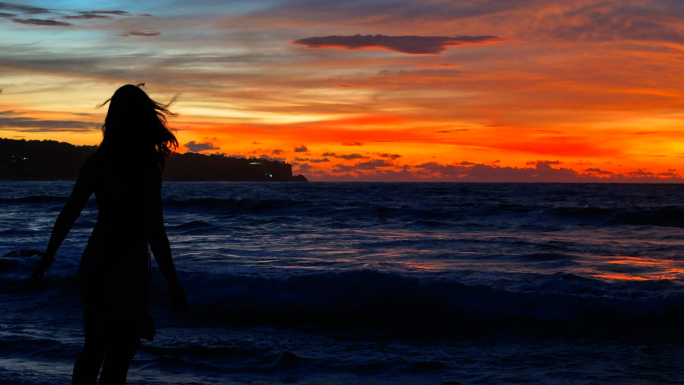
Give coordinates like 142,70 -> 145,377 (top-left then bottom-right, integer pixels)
147,181 -> 187,313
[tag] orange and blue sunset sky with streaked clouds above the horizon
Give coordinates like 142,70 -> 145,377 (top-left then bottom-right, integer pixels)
0,0 -> 684,182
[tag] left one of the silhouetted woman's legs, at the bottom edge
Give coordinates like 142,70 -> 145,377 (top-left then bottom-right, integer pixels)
71,306 -> 106,385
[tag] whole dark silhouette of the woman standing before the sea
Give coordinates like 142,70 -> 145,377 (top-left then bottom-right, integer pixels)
33,84 -> 186,384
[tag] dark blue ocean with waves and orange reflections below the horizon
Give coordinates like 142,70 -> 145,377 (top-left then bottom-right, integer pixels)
0,182 -> 684,385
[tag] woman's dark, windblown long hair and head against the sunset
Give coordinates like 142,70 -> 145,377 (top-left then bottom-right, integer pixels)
100,83 -> 178,168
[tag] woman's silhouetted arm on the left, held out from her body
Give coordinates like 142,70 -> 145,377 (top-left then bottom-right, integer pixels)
31,161 -> 93,286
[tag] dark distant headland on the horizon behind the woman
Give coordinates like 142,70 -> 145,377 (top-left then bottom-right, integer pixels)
0,138 -> 307,182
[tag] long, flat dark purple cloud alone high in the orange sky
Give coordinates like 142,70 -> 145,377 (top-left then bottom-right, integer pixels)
292,35 -> 504,55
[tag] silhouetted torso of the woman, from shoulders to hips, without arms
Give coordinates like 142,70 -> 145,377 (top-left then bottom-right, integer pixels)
77,148 -> 161,312
